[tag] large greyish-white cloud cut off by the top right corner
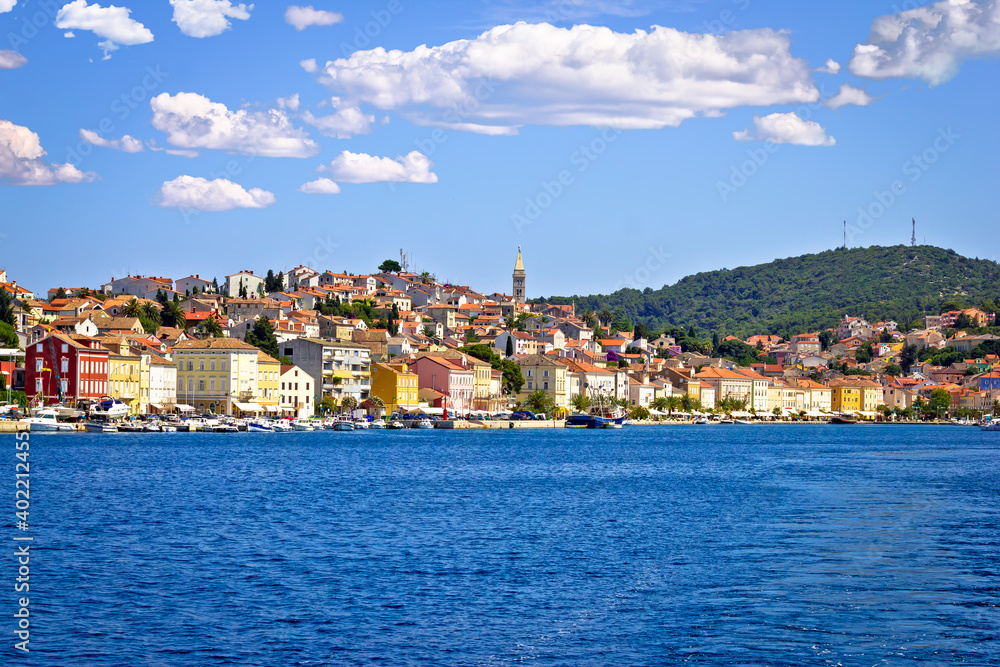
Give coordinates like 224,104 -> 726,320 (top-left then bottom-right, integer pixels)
849,0 -> 1000,86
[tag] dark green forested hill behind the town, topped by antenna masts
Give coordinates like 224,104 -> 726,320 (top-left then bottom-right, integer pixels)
537,246 -> 1000,337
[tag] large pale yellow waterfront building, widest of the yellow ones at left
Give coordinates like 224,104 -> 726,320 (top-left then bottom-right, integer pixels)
173,338 -> 263,415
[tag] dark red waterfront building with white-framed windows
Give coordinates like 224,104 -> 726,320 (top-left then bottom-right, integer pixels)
24,333 -> 109,403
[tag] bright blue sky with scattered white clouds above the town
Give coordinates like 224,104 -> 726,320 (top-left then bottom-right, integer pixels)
0,0 -> 1000,296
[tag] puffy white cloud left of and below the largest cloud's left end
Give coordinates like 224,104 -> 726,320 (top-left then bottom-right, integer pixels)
149,93 -> 319,157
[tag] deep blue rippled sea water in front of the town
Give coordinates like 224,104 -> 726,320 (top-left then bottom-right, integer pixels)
7,426 -> 1000,666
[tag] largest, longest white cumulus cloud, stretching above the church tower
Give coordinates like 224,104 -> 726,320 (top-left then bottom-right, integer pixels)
312,23 -> 819,134
